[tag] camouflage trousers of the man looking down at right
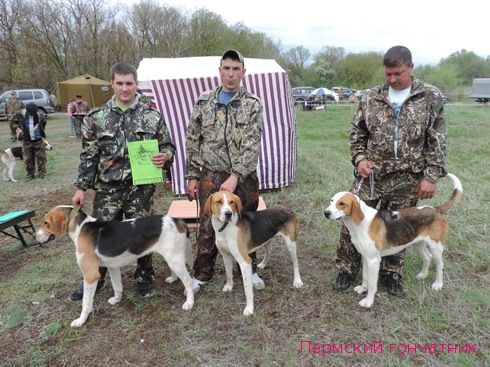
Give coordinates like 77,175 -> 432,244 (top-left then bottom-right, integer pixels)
334,173 -> 423,277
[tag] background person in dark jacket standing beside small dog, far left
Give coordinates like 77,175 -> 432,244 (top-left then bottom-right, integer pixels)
12,102 -> 46,182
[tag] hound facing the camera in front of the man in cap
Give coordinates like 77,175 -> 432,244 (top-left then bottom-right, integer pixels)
203,191 -> 303,316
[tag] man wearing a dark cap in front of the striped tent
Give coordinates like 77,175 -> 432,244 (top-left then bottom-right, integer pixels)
186,50 -> 265,292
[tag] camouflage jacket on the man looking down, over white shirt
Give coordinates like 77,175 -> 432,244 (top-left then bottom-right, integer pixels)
350,79 -> 447,182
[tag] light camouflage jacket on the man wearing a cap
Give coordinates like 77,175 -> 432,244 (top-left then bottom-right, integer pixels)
186,87 -> 262,181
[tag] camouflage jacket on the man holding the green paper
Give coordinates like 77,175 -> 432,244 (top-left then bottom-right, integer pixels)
74,95 -> 175,190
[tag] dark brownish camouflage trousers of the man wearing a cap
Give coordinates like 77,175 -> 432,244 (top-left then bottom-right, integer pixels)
193,169 -> 259,281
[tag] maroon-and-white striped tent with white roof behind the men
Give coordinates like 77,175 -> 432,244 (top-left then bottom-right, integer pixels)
138,56 -> 296,195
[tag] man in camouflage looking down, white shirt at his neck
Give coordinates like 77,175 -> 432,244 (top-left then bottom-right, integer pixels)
333,46 -> 446,298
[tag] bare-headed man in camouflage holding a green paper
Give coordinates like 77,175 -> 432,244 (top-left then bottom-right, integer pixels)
70,63 -> 175,300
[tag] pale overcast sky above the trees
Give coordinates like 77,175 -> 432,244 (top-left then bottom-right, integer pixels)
119,0 -> 490,66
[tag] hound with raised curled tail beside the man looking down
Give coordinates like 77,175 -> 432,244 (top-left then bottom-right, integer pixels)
324,173 -> 463,308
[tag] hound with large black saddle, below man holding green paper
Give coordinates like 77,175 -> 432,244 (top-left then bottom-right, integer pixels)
35,205 -> 194,327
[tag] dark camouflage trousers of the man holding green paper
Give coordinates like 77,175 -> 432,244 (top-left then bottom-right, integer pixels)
92,184 -> 155,284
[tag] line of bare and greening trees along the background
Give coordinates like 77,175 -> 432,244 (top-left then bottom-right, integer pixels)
0,0 -> 490,98
